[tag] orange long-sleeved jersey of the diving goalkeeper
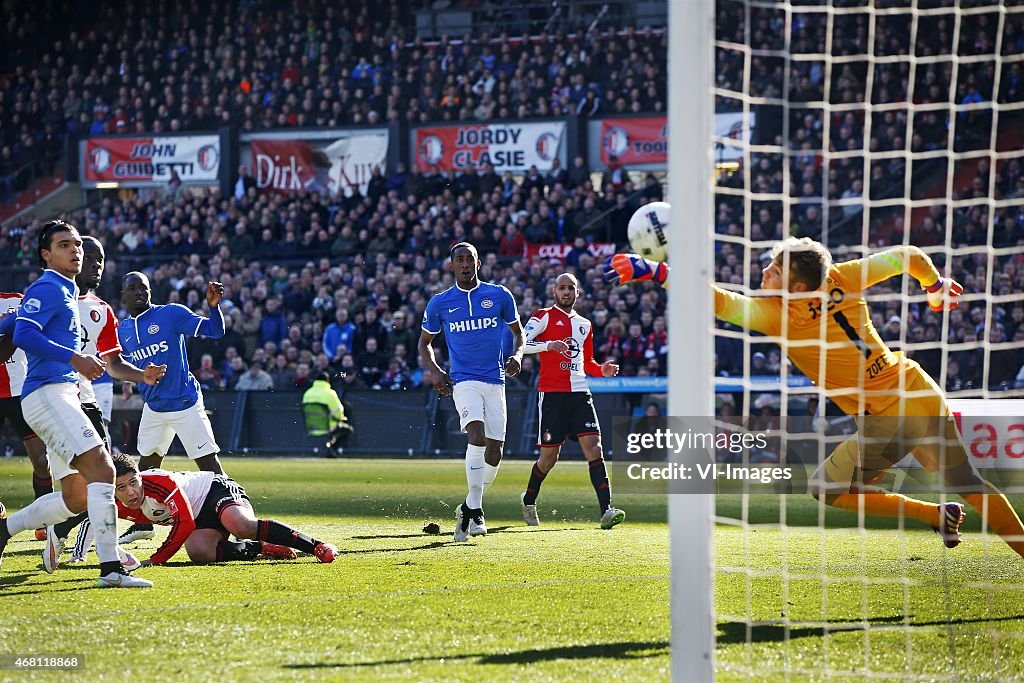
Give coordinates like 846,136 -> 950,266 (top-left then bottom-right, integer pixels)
715,247 -> 939,415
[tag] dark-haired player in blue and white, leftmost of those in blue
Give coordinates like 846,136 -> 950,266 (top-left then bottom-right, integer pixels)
0,220 -> 162,588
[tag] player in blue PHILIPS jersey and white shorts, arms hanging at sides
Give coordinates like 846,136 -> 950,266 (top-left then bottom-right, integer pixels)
419,242 -> 523,541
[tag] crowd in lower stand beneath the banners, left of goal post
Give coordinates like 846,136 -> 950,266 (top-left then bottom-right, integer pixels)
0,159 -> 668,390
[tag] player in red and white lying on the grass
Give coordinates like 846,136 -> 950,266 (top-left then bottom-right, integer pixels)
114,454 -> 338,566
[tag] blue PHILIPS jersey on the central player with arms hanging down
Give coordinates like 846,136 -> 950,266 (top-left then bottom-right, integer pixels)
423,283 -> 519,384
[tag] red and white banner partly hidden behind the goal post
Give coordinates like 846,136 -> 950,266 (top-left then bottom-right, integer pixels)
601,112 -> 756,166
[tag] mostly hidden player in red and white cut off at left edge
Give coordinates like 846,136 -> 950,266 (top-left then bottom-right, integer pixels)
0,292 -> 53,511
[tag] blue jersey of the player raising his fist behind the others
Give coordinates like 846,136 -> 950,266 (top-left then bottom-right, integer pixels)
118,303 -> 206,413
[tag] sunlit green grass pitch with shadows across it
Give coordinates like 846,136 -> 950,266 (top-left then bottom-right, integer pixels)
0,458 -> 1024,682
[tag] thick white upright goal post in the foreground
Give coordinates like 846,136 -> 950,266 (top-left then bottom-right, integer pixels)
668,0 -> 715,683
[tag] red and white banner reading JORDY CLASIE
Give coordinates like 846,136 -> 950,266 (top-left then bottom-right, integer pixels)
415,121 -> 565,175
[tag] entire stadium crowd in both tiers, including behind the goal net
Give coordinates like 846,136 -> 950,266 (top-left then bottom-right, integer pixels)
0,0 -> 1024,401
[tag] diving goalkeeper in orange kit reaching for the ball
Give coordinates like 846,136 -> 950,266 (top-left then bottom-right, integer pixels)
605,238 -> 1024,557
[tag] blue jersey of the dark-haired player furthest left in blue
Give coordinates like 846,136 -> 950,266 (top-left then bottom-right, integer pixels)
17,268 -> 80,398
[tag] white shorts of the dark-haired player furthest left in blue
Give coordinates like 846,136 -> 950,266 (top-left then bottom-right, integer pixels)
22,382 -> 103,479
